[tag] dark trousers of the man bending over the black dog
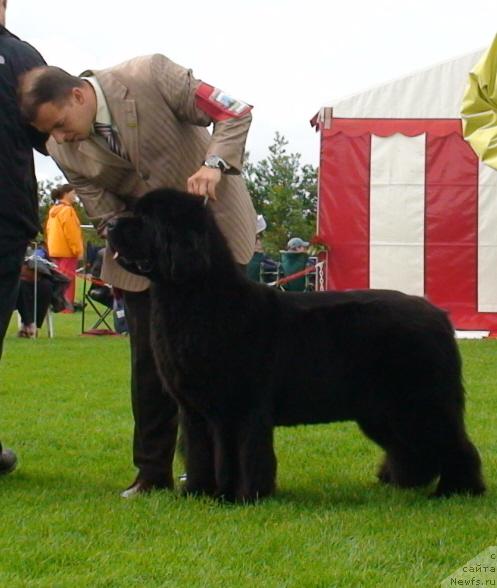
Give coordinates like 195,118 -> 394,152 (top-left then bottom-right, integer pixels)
124,290 -> 178,487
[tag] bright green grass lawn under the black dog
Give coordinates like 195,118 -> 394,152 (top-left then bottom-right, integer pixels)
0,314 -> 497,588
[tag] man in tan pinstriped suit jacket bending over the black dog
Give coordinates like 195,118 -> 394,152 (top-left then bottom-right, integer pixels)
20,55 -> 256,498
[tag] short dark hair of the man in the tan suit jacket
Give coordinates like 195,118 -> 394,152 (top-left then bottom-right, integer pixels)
19,65 -> 84,122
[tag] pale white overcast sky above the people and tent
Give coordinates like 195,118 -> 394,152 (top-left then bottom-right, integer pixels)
7,0 -> 497,179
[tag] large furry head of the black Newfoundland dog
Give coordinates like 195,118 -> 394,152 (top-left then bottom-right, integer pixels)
108,189 -> 211,283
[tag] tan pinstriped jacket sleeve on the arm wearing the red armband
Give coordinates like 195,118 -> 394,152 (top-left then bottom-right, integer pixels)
151,55 -> 252,174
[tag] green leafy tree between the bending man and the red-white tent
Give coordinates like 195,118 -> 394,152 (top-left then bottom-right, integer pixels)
243,132 -> 317,255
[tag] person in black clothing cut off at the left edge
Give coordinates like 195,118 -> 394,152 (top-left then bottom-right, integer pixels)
0,0 -> 47,474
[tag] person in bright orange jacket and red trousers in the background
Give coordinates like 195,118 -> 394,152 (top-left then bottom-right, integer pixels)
46,184 -> 83,312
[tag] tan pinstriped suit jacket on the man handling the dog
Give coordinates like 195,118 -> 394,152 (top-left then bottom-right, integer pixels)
48,55 -> 256,291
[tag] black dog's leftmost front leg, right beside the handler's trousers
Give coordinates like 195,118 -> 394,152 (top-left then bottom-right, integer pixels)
181,409 -> 216,496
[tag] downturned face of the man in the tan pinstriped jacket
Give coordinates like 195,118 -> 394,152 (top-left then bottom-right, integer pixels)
33,88 -> 95,144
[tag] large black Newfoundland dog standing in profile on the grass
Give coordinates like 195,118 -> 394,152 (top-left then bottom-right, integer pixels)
109,189 -> 485,501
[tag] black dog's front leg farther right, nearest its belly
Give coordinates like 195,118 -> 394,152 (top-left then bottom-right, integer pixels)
236,411 -> 276,502
